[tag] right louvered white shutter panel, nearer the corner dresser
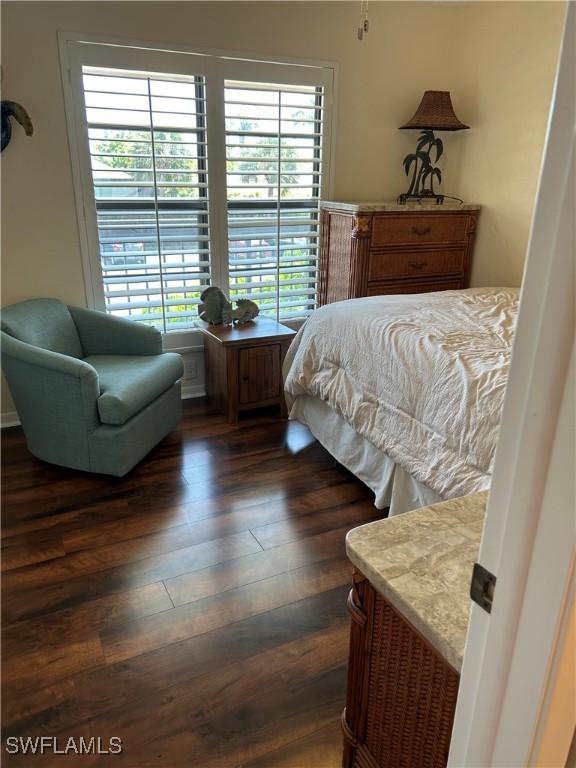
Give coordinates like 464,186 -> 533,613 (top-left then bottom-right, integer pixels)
224,80 -> 324,319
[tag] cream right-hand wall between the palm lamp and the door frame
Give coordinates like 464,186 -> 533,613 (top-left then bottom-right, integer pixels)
438,2 -> 565,286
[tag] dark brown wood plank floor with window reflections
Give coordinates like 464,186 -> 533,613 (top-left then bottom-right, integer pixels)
2,401 -> 381,768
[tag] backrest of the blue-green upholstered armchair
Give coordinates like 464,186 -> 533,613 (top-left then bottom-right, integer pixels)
2,299 -> 83,358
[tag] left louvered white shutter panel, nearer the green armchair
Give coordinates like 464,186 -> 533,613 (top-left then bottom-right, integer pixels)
82,66 -> 210,332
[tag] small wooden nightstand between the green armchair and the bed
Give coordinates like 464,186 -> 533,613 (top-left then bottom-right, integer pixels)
200,317 -> 296,423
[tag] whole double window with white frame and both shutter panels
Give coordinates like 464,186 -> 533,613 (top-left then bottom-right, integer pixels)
66,40 -> 333,333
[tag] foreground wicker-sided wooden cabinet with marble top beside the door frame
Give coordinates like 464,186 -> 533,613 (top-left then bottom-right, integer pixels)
342,493 -> 487,768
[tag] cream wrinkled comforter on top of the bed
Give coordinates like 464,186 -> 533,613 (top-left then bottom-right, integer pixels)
284,288 -> 518,499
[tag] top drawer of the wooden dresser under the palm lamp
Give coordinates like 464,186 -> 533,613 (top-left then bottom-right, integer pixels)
372,214 -> 468,245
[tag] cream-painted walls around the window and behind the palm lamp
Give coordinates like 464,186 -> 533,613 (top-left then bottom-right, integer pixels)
1,1 -> 563,420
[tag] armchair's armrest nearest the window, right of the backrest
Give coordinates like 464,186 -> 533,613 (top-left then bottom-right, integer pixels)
68,307 -> 162,356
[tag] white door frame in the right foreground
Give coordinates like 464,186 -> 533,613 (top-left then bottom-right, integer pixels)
449,3 -> 576,768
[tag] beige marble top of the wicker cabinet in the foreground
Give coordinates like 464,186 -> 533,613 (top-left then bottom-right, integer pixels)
346,492 -> 488,671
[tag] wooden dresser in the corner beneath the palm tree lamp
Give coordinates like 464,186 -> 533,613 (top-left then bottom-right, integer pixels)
318,202 -> 480,305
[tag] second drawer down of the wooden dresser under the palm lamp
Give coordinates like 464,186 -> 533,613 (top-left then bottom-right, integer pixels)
368,248 -> 466,280
